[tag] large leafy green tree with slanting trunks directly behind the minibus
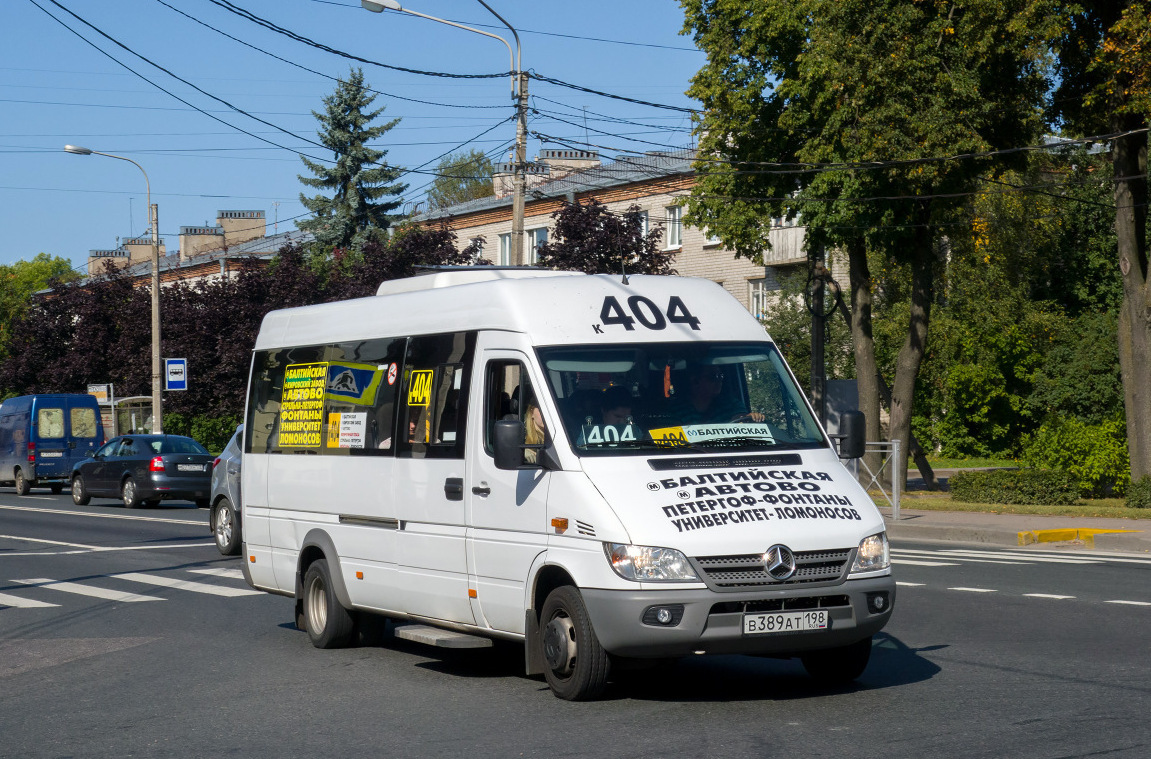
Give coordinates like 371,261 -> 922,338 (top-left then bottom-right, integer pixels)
681,0 -> 1054,486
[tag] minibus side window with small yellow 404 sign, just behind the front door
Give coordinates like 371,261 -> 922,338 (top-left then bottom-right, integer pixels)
396,332 -> 475,458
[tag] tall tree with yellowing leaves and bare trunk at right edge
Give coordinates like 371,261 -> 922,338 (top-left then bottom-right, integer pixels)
1052,0 -> 1151,480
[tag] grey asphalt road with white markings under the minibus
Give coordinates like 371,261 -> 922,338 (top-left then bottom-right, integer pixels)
0,488 -> 1151,759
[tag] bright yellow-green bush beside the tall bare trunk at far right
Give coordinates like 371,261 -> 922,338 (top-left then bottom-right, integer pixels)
1023,419 -> 1131,498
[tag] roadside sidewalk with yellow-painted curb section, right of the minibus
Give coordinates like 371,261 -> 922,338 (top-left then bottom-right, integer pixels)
875,469 -> 1151,554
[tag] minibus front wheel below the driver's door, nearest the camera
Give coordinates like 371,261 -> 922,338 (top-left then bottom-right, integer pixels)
540,585 -> 611,701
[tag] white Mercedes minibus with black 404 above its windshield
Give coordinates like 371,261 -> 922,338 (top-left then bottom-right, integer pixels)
242,267 -> 895,700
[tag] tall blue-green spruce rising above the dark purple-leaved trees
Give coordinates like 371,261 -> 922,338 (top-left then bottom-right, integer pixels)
296,69 -> 407,250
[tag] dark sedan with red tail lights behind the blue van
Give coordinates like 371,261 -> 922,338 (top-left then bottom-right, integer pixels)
71,434 -> 212,509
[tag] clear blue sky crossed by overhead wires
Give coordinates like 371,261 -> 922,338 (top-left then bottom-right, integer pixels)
0,0 -> 704,270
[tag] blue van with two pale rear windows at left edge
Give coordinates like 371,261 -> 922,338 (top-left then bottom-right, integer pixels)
0,393 -> 104,495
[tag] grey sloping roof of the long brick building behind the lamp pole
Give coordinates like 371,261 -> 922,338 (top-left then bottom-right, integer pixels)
412,149 -> 695,221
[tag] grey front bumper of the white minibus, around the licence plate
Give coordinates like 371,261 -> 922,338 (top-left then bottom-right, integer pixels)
581,575 -> 895,658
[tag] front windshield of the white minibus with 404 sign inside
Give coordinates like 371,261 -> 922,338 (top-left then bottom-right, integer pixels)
538,342 -> 826,455
